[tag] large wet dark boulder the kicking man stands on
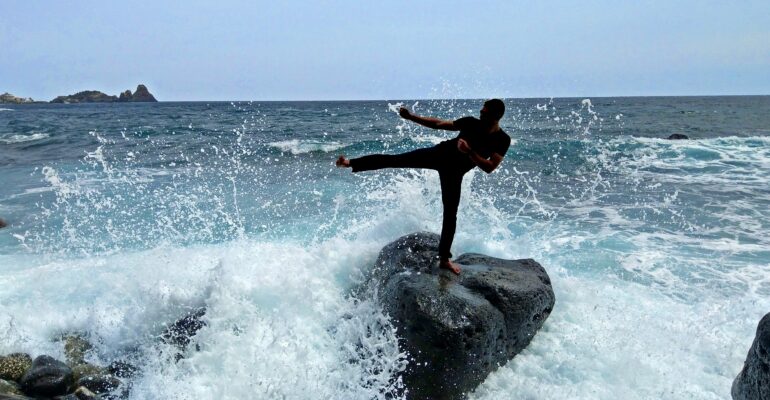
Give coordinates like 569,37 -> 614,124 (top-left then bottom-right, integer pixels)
370,233 -> 554,399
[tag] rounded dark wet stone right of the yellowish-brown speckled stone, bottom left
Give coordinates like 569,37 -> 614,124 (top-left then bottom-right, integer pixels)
20,356 -> 74,397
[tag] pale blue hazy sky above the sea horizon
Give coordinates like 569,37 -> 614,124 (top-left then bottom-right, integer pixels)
0,0 -> 770,101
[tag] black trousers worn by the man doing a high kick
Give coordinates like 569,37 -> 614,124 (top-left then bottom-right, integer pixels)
350,147 -> 467,259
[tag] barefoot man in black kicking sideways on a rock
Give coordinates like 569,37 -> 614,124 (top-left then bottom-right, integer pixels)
336,99 -> 511,274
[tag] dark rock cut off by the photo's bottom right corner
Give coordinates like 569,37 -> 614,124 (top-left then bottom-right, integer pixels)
732,313 -> 770,400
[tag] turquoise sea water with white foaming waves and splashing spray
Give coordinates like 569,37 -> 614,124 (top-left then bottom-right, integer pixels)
0,97 -> 770,399
